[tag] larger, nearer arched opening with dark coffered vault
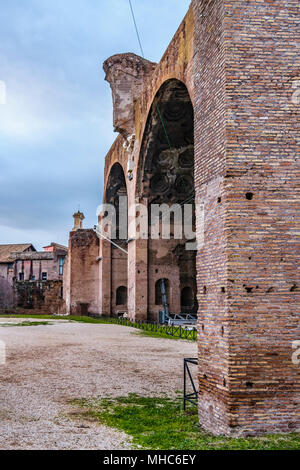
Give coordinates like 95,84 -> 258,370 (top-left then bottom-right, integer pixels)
136,79 -> 197,320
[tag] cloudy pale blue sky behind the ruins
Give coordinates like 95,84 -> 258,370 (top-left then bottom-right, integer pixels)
0,0 -> 190,249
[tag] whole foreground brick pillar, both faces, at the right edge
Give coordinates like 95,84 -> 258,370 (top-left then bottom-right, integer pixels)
194,0 -> 300,434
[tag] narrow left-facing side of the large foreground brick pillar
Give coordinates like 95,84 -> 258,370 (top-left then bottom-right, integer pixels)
193,0 -> 230,433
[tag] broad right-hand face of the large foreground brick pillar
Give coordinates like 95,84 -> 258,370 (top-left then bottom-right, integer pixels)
225,0 -> 300,433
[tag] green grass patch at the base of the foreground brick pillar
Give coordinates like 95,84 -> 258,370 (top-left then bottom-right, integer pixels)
72,394 -> 300,450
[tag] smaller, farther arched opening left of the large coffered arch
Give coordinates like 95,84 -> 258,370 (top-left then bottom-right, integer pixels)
105,163 -> 128,317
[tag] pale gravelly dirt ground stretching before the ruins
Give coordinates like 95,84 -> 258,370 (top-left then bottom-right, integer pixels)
0,319 -> 197,449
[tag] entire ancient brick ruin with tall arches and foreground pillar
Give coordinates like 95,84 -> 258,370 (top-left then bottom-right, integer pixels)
65,0 -> 300,435
